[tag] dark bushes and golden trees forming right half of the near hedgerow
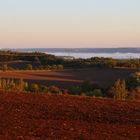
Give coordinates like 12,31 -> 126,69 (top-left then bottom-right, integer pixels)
70,72 -> 140,100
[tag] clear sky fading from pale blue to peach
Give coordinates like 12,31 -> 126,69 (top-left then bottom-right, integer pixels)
0,0 -> 140,48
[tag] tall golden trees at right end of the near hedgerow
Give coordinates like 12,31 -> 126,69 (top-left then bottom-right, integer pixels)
107,72 -> 140,100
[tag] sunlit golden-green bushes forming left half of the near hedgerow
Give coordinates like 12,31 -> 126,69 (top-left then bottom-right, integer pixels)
0,78 -> 67,95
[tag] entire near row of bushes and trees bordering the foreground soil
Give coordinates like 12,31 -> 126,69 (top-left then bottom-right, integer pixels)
0,72 -> 140,100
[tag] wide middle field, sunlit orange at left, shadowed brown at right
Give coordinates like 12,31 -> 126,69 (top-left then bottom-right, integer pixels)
0,68 -> 137,88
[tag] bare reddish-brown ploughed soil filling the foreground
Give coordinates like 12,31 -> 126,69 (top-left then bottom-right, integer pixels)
0,93 -> 140,140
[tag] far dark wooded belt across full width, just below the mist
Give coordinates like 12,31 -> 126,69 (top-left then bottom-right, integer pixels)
0,51 -> 140,69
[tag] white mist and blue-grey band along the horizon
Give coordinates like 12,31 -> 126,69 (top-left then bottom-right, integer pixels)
4,48 -> 140,59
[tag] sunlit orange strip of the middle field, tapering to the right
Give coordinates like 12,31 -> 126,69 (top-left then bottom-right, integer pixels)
0,71 -> 82,83
